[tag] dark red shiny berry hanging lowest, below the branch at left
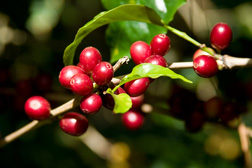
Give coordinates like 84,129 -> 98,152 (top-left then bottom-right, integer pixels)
59,112 -> 88,136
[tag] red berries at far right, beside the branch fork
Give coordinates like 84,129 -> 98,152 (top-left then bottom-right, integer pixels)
193,23 -> 232,78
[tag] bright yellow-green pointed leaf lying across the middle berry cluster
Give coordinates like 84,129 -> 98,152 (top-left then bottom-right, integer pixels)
112,63 -> 192,92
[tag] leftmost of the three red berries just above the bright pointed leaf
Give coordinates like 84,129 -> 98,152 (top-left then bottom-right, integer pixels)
130,41 -> 151,64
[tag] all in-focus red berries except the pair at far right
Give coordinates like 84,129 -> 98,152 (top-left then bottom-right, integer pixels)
25,34 -> 170,136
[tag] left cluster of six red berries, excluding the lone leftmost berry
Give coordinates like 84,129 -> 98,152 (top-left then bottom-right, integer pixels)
59,47 -> 114,136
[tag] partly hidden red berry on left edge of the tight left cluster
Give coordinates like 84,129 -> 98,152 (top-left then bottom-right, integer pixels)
59,65 -> 84,89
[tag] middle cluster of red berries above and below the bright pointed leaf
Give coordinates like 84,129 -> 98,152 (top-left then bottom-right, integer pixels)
122,34 -> 171,129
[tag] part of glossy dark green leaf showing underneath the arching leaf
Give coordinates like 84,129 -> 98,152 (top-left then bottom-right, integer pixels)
106,21 -> 167,63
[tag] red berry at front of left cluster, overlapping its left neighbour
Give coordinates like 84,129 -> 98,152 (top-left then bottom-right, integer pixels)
70,73 -> 93,96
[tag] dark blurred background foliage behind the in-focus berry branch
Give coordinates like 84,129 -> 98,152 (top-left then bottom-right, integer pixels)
0,0 -> 252,168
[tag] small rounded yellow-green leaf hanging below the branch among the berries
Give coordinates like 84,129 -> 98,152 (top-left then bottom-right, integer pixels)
107,88 -> 132,114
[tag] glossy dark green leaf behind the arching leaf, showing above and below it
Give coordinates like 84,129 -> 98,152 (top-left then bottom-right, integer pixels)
102,0 -> 186,63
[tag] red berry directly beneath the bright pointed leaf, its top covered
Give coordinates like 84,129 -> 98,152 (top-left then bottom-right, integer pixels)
124,78 -> 150,97
